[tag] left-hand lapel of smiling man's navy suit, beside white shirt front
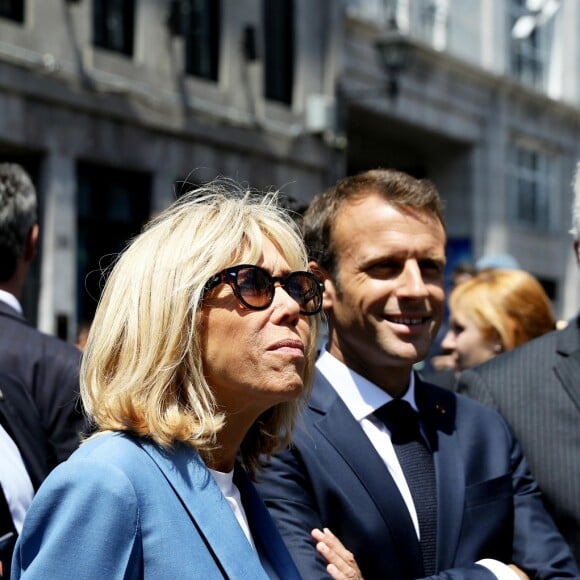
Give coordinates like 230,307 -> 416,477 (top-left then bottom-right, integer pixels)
315,375 -> 422,578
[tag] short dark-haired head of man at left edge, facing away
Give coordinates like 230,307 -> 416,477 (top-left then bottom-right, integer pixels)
0,163 -> 38,299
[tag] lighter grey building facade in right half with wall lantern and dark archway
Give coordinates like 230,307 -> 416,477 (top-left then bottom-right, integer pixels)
341,0 -> 580,318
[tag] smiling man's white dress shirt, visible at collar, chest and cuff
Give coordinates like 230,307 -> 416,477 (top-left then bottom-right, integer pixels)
316,350 -> 518,580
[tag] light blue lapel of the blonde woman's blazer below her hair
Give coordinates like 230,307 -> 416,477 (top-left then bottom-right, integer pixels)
139,441 -> 268,579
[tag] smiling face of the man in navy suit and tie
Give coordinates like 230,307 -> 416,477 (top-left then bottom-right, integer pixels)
324,194 -> 445,386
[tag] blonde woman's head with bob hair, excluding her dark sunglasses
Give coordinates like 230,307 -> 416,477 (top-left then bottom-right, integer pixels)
81,182 -> 318,473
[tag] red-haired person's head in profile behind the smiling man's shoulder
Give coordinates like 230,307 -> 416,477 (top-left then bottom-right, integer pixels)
441,269 -> 556,372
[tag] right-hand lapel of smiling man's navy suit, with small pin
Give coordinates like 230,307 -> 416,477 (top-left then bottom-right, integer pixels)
415,376 -> 465,570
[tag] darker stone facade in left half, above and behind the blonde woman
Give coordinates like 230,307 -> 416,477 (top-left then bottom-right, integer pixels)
0,0 -> 340,340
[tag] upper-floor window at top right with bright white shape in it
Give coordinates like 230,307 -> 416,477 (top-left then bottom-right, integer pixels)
509,0 -> 558,90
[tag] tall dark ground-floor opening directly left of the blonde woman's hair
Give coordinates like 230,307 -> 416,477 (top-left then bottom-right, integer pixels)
77,163 -> 151,323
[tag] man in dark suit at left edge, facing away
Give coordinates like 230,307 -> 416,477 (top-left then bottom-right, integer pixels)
0,163 -> 85,468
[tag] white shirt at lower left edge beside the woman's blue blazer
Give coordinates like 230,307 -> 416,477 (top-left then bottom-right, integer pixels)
0,425 -> 34,534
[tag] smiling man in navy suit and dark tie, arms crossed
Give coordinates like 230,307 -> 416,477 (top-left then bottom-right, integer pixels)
259,170 -> 580,580
